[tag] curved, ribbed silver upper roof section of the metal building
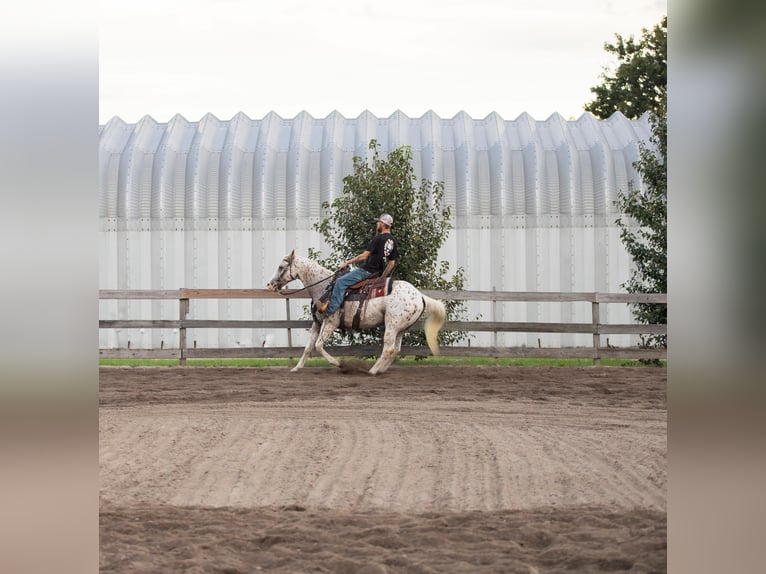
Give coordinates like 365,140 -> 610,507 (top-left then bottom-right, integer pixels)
99,111 -> 651,229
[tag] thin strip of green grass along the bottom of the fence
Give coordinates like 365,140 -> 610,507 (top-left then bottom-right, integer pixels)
98,357 -> 667,367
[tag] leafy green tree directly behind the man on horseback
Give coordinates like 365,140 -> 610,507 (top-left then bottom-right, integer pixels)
309,139 -> 466,345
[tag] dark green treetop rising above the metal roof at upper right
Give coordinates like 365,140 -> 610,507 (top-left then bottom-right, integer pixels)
585,16 -> 668,119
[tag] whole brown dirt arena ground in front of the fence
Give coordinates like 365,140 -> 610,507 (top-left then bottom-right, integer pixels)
99,365 -> 667,574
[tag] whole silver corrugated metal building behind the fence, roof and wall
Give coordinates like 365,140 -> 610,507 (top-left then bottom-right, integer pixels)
99,112 -> 651,347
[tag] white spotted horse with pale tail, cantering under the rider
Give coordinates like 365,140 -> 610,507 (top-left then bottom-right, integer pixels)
266,249 -> 447,375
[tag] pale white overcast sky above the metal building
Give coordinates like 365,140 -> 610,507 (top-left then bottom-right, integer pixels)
99,0 -> 667,124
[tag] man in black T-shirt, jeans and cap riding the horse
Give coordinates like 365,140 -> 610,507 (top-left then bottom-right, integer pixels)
319,213 -> 399,317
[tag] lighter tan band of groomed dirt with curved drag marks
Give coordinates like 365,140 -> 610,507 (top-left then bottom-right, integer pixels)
100,401 -> 665,512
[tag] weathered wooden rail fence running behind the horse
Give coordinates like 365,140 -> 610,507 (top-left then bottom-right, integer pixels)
99,289 -> 667,365
